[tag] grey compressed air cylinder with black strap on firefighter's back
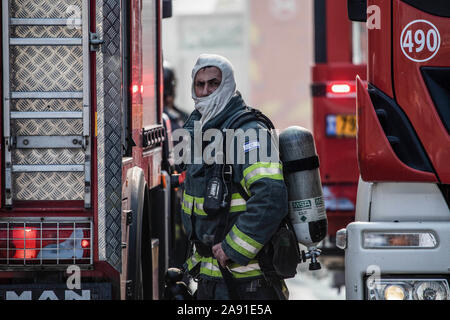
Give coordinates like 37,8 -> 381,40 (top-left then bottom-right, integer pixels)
279,126 -> 328,250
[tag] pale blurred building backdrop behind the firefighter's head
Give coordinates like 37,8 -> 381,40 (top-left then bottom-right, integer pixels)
163,0 -> 314,129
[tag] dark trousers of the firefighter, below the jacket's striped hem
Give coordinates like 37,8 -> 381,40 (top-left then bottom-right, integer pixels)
197,279 -> 279,300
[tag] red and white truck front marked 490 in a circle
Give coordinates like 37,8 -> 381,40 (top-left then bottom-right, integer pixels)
337,0 -> 450,300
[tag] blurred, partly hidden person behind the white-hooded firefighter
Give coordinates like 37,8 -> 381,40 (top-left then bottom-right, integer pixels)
163,61 -> 189,131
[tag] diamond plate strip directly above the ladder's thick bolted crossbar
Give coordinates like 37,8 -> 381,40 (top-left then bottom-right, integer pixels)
11,119 -> 83,136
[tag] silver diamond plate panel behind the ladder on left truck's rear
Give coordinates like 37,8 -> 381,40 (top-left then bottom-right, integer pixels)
5,0 -> 87,204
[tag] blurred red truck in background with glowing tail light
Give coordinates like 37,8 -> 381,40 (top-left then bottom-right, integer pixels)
312,0 -> 366,278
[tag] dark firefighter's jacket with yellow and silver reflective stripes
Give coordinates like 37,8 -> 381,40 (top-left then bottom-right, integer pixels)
181,94 -> 288,279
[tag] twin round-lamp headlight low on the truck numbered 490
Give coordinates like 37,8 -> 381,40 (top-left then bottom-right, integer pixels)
366,278 -> 450,300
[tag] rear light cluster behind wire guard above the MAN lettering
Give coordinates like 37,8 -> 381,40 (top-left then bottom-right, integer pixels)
0,219 -> 93,267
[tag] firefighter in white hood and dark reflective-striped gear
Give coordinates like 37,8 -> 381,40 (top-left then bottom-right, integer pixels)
182,54 -> 288,300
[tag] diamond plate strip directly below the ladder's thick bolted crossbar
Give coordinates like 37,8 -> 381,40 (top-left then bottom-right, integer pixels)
12,149 -> 85,165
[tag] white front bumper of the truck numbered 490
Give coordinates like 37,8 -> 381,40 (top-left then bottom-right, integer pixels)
345,221 -> 450,300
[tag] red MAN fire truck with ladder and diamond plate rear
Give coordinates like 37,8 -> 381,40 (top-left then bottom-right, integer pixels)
0,0 -> 176,300
